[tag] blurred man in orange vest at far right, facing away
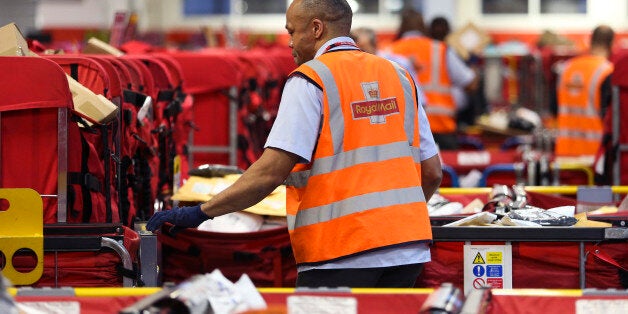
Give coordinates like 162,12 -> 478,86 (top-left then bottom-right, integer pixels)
554,25 -> 614,157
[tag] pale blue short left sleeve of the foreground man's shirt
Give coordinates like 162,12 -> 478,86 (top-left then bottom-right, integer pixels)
264,75 -> 323,163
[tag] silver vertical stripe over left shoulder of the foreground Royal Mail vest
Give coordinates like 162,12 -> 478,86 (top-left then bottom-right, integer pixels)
305,59 -> 345,154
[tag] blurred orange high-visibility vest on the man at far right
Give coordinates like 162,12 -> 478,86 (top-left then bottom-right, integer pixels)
555,55 -> 613,156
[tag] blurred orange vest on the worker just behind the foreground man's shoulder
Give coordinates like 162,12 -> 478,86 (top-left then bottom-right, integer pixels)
390,36 -> 456,133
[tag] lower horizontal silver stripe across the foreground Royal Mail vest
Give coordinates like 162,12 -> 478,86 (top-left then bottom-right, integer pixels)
287,187 -> 425,230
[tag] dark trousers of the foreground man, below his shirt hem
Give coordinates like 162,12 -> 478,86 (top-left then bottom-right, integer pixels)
297,264 -> 423,288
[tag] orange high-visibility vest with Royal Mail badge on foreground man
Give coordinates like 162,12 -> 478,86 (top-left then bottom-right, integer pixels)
286,50 -> 432,264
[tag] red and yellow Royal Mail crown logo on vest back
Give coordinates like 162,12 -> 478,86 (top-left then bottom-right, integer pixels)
351,82 -> 399,124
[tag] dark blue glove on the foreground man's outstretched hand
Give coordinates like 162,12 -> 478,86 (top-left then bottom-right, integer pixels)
146,205 -> 211,231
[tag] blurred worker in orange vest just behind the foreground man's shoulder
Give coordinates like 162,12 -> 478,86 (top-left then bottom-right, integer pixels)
389,9 -> 478,150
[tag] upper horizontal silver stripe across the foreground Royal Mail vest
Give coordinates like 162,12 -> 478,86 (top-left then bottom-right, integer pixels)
286,142 -> 420,188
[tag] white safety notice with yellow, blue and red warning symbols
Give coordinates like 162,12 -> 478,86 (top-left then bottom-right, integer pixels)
464,242 -> 512,294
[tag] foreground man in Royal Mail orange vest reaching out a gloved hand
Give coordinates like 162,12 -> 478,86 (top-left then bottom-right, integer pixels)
146,0 -> 442,287
